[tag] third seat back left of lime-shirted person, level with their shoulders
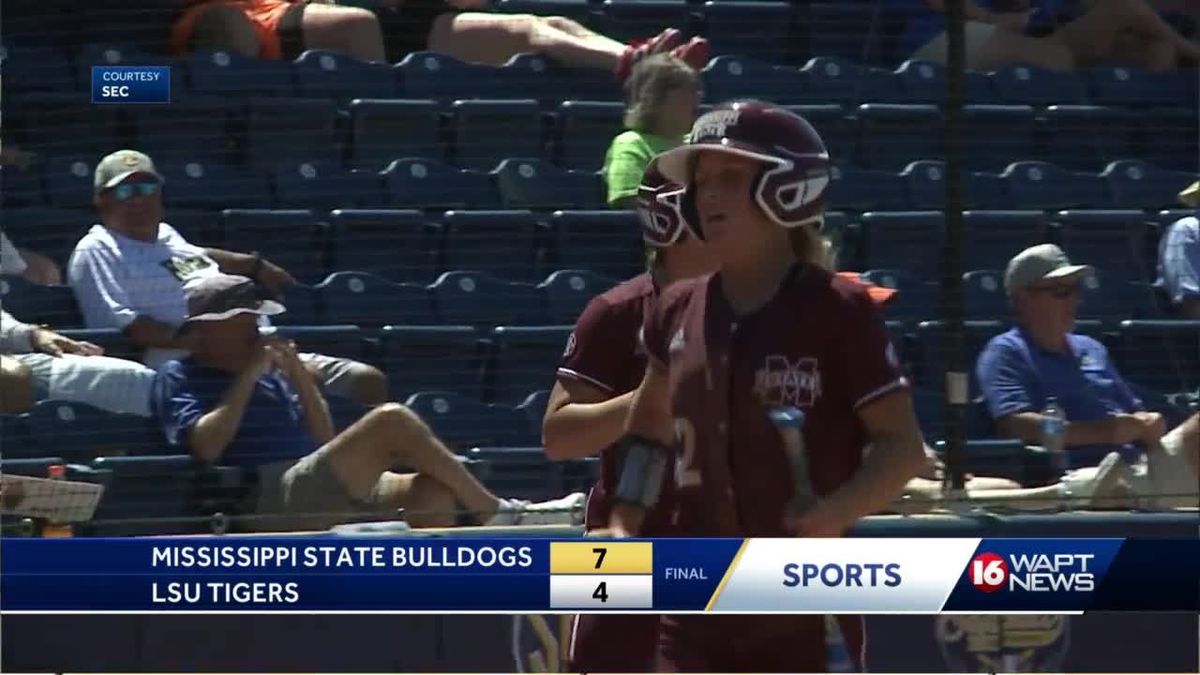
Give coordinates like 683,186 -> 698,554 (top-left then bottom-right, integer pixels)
349,100 -> 442,169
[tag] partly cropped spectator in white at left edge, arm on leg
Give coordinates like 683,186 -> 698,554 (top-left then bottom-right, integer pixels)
0,310 -> 154,417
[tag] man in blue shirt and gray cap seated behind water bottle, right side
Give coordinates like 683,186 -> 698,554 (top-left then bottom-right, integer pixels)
976,244 -> 1200,506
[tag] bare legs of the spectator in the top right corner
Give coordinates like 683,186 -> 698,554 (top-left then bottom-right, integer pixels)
1052,0 -> 1200,67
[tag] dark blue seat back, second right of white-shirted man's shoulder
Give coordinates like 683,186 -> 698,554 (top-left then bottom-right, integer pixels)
329,209 -> 442,283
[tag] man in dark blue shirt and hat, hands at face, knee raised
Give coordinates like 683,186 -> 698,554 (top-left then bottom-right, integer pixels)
154,274 -> 583,530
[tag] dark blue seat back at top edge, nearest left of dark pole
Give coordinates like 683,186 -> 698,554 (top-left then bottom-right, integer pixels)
804,0 -> 889,64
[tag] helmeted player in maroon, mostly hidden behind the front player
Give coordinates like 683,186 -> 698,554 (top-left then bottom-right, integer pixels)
542,162 -> 715,673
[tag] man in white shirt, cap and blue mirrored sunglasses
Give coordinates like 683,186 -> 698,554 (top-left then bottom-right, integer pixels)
68,150 -> 388,405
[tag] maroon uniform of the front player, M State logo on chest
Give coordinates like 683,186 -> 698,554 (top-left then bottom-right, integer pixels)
643,265 -> 907,671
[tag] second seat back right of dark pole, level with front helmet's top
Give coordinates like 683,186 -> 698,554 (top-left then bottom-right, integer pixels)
1038,106 -> 1136,171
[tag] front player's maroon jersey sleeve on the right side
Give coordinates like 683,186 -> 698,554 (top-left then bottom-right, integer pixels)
842,288 -> 908,410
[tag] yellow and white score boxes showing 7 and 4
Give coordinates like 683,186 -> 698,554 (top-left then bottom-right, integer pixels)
550,540 -> 654,610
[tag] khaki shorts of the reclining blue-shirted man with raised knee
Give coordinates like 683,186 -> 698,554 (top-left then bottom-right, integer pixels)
251,447 -> 397,532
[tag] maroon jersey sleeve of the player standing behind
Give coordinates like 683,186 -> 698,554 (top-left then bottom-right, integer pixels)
558,295 -> 642,395
